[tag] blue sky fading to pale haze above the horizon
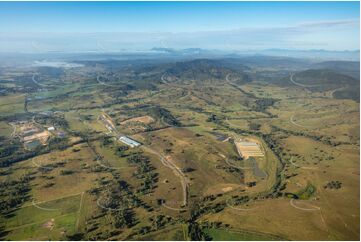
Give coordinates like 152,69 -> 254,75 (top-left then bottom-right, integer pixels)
0,2 -> 360,52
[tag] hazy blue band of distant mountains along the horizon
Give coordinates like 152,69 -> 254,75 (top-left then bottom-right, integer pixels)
0,47 -> 360,69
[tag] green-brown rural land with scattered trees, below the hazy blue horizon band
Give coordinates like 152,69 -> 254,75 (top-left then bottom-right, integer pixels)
0,57 -> 360,240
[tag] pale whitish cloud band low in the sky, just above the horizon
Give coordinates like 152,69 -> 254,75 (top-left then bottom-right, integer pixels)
0,19 -> 359,52
